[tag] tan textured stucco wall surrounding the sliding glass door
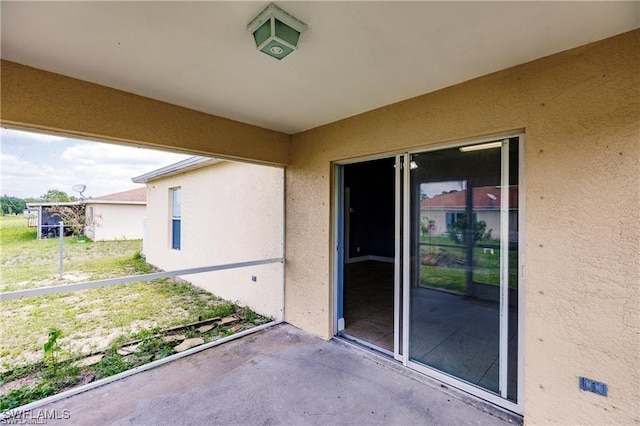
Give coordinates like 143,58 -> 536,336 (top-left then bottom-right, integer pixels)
286,31 -> 640,424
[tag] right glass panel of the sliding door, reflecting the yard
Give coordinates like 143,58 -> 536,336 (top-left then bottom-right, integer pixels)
405,138 -> 519,402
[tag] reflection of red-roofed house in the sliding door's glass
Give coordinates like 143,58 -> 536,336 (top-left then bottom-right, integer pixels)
420,183 -> 518,241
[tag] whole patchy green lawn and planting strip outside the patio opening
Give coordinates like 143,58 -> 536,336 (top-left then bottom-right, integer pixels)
0,217 -> 268,411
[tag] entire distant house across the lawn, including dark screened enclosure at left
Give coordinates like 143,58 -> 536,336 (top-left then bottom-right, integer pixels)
27,188 -> 147,241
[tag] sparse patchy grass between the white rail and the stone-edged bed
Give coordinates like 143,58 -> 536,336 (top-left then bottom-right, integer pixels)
0,279 -> 260,372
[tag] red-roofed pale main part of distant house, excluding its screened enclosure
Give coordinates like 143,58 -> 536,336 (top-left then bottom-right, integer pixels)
83,188 -> 147,241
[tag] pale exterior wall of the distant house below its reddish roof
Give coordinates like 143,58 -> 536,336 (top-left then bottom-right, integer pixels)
86,203 -> 146,241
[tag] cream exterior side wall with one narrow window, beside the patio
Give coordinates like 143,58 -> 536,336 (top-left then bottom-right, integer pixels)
144,162 -> 284,318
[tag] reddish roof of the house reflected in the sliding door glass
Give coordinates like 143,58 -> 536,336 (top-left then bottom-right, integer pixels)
420,186 -> 518,210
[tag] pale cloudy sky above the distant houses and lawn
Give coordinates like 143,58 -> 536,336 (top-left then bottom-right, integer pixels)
0,128 -> 190,198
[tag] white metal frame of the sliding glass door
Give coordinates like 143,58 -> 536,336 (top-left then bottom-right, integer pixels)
331,131 -> 526,415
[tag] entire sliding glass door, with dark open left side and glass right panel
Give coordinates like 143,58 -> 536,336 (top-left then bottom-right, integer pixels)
336,137 -> 522,411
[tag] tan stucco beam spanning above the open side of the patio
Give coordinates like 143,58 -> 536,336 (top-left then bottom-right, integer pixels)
0,60 -> 290,165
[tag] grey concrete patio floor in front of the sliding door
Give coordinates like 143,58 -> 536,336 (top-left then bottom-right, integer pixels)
36,324 -> 520,425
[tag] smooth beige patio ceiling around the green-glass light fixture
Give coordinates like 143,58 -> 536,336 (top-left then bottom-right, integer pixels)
0,1 -> 640,133
